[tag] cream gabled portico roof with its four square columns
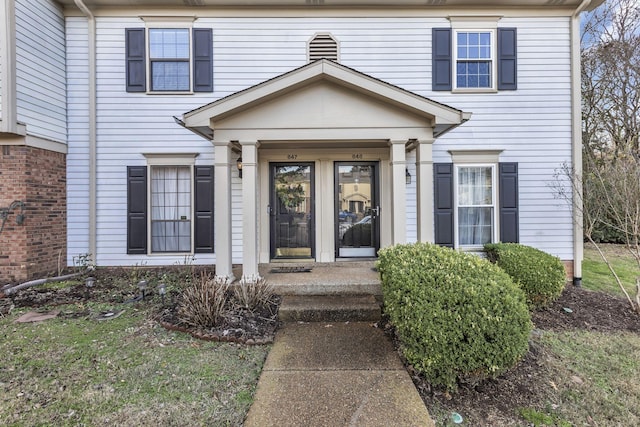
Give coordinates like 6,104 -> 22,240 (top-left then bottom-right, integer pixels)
176,59 -> 471,280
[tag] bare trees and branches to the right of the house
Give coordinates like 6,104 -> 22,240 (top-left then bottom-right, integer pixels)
552,0 -> 640,314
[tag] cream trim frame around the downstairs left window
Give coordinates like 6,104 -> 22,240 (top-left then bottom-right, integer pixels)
143,153 -> 198,257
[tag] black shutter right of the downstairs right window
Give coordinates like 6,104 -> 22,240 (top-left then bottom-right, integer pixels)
499,163 -> 520,243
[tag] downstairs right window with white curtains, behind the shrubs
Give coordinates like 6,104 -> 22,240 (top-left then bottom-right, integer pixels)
455,165 -> 496,248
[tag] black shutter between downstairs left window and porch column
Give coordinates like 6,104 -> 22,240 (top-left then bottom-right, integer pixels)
194,166 -> 213,253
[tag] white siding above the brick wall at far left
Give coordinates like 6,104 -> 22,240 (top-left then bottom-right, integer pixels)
16,0 -> 67,143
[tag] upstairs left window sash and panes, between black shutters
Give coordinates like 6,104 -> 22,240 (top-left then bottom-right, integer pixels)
149,28 -> 191,92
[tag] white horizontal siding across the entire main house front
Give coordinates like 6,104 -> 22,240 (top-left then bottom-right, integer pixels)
67,14 -> 573,265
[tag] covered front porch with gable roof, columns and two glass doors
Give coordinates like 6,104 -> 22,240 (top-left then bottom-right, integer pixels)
182,60 -> 470,282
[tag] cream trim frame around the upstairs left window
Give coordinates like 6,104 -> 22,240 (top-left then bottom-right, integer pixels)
140,16 -> 196,95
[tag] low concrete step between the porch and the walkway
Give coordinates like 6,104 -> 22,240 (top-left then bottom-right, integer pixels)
278,295 -> 380,322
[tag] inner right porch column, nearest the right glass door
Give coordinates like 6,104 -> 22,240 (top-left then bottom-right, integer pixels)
390,141 -> 407,245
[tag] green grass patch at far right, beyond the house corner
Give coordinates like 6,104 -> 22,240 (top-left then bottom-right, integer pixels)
582,244 -> 640,296
